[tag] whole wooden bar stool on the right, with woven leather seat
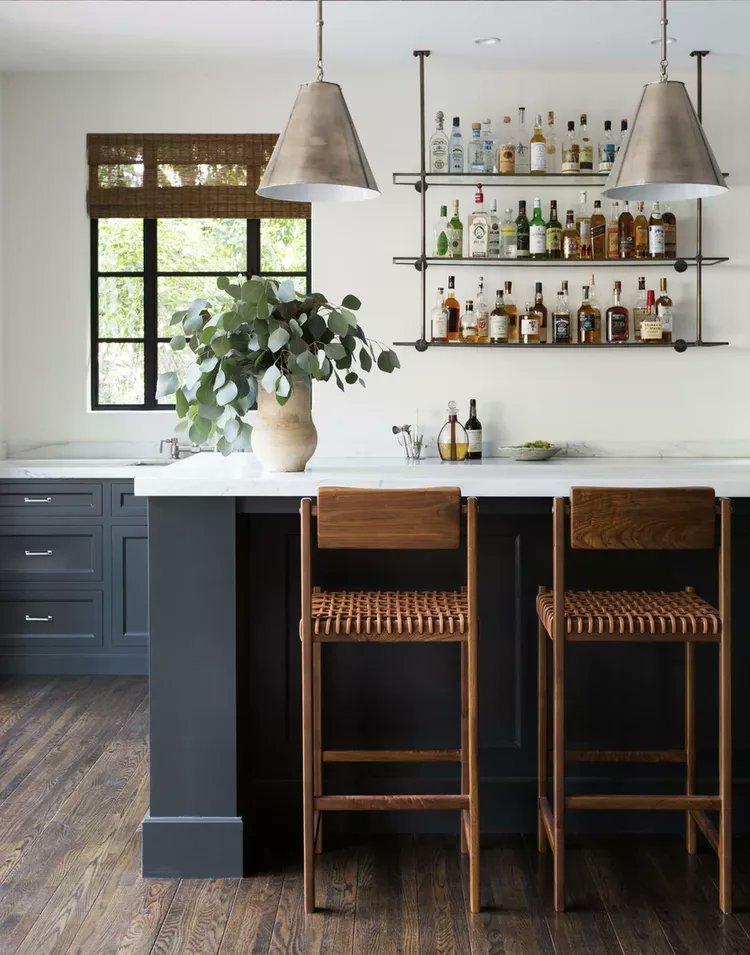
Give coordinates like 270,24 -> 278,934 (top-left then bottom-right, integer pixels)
537,487 -> 732,913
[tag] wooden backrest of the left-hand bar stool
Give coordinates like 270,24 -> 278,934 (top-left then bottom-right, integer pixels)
317,487 -> 461,550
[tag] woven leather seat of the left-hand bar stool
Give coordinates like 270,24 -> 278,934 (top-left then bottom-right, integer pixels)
312,590 -> 469,640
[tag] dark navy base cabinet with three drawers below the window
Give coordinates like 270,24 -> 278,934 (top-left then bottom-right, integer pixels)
0,478 -> 148,674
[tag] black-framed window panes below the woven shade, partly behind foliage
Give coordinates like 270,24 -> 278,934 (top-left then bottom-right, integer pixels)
91,218 -> 311,411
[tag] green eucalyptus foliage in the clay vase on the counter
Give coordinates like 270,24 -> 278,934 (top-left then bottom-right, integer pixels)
156,276 -> 400,454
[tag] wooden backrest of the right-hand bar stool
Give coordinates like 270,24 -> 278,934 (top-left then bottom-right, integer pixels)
570,487 -> 716,550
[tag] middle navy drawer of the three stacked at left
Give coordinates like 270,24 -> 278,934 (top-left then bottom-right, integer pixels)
0,525 -> 102,581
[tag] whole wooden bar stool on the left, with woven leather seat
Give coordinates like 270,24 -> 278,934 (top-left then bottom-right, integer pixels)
300,487 -> 479,912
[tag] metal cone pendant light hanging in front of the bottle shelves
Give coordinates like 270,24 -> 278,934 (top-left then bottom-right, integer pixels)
602,0 -> 727,201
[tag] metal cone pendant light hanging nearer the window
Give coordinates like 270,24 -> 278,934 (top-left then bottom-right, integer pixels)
258,0 -> 380,202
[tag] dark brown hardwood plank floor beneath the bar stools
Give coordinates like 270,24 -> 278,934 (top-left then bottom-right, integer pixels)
0,677 -> 750,955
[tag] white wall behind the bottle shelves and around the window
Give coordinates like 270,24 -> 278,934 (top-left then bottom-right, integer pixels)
0,60 -> 750,454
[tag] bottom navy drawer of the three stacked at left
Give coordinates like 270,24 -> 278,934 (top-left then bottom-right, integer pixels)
0,590 -> 102,647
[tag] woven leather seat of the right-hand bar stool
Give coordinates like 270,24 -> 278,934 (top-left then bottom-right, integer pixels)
537,590 -> 721,640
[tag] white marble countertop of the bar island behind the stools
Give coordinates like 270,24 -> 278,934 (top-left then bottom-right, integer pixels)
135,454 -> 750,497
